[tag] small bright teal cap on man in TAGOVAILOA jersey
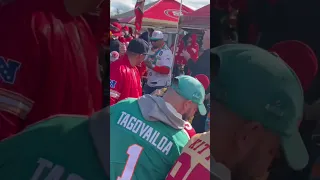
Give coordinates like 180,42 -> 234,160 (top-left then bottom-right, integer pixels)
171,75 -> 207,115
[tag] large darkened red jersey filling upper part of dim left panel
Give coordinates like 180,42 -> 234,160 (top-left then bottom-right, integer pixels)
0,0 -> 102,139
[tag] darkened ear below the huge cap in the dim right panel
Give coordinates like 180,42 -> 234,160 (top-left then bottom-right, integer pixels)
236,122 -> 264,156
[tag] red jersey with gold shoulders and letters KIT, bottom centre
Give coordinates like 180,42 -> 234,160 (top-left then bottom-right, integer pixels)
166,132 -> 210,180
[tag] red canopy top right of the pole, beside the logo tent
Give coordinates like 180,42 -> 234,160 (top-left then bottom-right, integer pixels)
180,4 -> 210,29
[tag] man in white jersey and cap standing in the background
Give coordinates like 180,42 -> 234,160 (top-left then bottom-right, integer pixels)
144,31 -> 173,94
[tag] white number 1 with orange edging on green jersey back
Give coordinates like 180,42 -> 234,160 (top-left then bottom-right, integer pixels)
117,144 -> 143,180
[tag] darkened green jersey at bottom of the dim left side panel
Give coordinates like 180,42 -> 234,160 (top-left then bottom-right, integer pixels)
0,116 -> 108,180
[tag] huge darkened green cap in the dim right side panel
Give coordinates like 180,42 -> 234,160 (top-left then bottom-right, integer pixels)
211,44 -> 309,170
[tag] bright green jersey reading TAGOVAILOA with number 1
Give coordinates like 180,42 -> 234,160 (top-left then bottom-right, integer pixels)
110,98 -> 189,180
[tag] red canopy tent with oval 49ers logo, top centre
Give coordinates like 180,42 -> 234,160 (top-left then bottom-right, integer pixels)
113,0 -> 193,27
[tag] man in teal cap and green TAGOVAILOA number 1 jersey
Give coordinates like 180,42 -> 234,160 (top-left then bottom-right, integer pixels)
110,76 -> 206,180
